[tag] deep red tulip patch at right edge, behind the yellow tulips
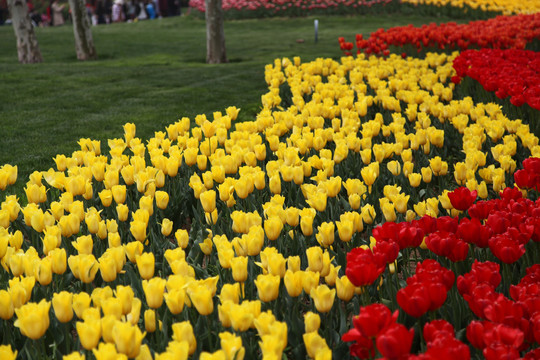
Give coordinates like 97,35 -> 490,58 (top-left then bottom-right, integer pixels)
453,49 -> 540,110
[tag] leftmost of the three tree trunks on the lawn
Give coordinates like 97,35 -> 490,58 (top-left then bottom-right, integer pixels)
8,0 -> 43,64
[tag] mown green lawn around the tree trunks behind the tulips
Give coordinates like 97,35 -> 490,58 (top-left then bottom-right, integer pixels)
0,14 -> 456,194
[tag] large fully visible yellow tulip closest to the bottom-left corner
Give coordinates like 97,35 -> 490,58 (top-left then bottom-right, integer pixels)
13,299 -> 51,340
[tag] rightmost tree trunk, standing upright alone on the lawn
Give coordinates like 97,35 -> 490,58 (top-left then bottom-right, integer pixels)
205,0 -> 227,64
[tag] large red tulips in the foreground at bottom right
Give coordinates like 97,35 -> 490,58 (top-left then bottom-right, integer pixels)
342,183 -> 540,359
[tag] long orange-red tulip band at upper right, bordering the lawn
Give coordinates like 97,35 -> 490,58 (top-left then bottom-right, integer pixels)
339,13 -> 540,55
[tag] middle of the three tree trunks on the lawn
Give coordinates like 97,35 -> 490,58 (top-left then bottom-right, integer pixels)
69,0 -> 97,60
